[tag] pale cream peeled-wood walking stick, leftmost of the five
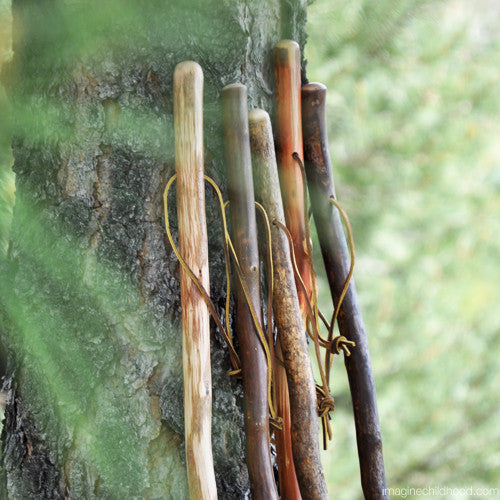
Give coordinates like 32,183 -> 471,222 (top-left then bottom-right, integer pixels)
174,61 -> 217,500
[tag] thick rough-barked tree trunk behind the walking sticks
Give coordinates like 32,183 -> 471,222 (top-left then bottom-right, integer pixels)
0,0 -> 306,499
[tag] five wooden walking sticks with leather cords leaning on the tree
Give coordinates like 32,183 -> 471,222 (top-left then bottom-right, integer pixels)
165,40 -> 386,500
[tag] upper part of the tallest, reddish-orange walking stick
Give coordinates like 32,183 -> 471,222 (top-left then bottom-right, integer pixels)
273,40 -> 314,320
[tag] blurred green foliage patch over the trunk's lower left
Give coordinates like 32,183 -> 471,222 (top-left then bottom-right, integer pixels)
0,192 -> 182,498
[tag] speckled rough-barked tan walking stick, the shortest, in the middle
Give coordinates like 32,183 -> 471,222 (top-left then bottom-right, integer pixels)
250,109 -> 328,499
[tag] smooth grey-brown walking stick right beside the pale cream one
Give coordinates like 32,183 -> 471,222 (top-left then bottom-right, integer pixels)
222,84 -> 278,500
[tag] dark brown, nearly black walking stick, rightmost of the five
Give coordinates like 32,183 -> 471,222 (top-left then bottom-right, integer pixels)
302,83 -> 388,499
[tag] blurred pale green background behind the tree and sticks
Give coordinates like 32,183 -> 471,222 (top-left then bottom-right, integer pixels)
0,0 -> 500,500
